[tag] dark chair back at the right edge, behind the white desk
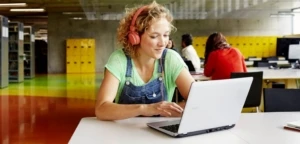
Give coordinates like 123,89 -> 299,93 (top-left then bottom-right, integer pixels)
263,88 -> 300,112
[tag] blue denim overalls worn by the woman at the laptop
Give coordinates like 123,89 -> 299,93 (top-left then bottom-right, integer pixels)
118,49 -> 168,104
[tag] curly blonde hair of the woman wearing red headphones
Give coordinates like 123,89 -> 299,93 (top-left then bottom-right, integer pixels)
117,1 -> 176,57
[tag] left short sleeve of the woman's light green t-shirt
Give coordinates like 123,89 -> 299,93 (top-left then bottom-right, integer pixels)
105,50 -> 127,81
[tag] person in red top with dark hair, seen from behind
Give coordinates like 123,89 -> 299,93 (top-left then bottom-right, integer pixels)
204,33 -> 247,80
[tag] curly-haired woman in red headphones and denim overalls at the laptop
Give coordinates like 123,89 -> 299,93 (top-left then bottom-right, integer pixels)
95,1 -> 195,120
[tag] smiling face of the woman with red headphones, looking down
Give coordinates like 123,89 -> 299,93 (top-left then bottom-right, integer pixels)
138,18 -> 171,59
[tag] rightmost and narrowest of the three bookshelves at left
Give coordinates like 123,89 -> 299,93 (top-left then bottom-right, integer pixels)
24,26 -> 35,79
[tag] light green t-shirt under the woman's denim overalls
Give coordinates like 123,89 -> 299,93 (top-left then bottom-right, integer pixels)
105,49 -> 187,102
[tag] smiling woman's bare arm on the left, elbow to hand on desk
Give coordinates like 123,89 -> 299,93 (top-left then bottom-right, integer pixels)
95,70 -> 183,120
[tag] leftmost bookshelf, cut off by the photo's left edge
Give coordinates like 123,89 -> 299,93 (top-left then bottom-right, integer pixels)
0,15 -> 8,88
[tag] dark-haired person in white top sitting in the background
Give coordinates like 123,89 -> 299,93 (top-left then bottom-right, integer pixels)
181,34 -> 201,72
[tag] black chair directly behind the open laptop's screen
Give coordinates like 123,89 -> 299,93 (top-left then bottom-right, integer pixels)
231,71 -> 263,112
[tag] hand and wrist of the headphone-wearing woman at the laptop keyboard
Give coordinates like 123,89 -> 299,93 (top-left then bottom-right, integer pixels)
143,101 -> 183,117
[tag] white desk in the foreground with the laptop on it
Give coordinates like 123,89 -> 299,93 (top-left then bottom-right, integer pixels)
69,112 -> 300,144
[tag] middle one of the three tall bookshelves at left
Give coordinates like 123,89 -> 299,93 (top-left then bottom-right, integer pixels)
8,22 -> 24,82
